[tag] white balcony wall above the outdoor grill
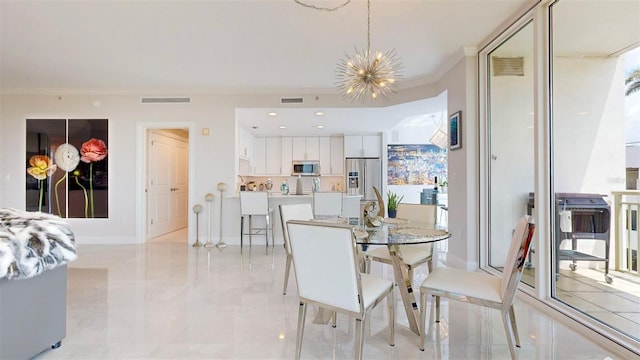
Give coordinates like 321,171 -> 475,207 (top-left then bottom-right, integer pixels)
553,58 -> 626,193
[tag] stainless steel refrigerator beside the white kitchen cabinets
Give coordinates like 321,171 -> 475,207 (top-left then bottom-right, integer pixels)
345,158 -> 382,201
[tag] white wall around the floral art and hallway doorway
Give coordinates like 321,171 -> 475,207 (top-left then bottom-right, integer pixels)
0,90 -> 450,244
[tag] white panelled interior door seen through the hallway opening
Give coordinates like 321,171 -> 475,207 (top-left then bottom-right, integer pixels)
147,131 -> 189,238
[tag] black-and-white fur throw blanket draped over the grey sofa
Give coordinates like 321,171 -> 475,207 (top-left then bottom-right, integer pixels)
0,209 -> 77,279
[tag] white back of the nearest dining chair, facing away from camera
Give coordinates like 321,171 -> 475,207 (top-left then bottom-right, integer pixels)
287,220 -> 364,314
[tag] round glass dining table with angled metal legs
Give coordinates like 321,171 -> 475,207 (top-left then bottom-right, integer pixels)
318,218 -> 451,335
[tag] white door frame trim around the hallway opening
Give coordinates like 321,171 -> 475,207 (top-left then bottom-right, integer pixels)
136,121 -> 195,244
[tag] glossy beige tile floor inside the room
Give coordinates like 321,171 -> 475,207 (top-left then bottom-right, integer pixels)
37,231 -> 618,359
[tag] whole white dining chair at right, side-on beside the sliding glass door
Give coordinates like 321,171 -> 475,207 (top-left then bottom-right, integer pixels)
420,215 -> 535,359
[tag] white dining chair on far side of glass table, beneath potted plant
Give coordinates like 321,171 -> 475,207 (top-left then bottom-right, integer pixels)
365,203 -> 437,284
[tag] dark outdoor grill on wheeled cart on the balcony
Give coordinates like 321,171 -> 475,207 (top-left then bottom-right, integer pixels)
555,193 -> 613,283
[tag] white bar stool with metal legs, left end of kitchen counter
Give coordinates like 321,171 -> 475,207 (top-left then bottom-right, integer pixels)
240,191 -> 273,254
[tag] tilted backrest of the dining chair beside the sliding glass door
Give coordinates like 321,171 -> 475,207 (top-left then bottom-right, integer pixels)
500,215 -> 535,304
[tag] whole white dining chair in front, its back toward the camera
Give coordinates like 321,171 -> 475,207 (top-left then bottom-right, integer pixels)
287,220 -> 395,359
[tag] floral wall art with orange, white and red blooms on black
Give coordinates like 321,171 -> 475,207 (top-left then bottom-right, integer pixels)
26,119 -> 109,218
